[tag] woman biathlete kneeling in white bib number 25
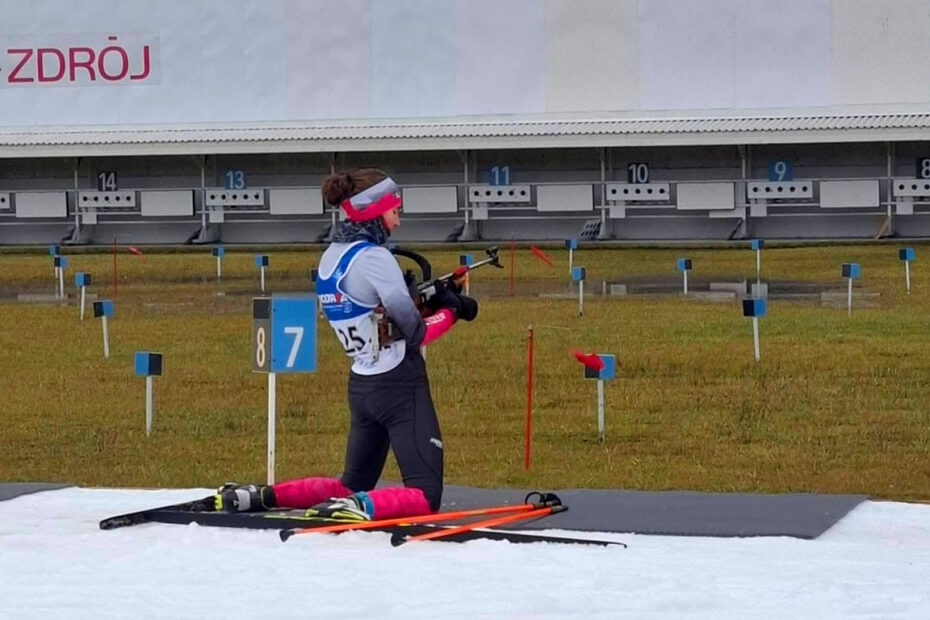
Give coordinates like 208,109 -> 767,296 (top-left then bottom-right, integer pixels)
216,169 -> 478,520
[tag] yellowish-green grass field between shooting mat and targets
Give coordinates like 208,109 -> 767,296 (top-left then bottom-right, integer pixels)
0,245 -> 930,500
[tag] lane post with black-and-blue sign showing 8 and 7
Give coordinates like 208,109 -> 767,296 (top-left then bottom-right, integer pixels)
252,294 -> 317,484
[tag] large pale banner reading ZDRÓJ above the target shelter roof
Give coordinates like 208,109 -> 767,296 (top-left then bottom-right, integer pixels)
0,0 -> 930,128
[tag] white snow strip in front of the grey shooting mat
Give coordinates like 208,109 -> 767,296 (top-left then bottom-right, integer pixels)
0,488 -> 930,620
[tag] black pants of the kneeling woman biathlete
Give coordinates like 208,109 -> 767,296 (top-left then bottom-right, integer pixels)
342,346 -> 442,510
